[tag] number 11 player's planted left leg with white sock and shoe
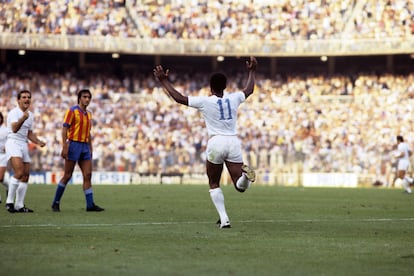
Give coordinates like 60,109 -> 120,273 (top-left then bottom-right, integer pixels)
206,160 -> 230,228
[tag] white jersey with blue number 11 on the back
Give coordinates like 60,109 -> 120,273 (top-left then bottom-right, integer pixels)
188,92 -> 246,137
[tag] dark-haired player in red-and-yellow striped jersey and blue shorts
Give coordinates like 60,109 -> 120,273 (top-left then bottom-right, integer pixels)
52,89 -> 104,212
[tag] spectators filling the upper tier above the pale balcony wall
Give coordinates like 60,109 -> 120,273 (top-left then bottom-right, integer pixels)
0,0 -> 414,40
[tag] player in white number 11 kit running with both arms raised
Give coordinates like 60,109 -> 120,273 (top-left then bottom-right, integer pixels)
153,57 -> 257,228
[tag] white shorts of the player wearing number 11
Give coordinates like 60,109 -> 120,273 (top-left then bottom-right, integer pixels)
206,135 -> 243,164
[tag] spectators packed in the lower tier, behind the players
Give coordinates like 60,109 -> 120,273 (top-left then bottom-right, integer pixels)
0,64 -> 414,188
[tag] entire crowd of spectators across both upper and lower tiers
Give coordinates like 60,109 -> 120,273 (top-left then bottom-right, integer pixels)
0,0 -> 414,188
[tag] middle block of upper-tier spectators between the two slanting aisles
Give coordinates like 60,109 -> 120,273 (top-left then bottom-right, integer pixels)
134,0 -> 355,40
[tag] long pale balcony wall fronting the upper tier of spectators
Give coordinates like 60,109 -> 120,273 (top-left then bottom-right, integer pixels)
0,33 -> 414,57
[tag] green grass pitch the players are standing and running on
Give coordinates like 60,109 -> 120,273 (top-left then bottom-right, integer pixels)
0,185 -> 414,275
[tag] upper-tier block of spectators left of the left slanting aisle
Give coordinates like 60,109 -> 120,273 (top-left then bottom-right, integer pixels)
0,0 -> 136,37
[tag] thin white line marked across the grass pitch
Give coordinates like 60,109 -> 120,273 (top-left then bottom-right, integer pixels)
0,218 -> 414,228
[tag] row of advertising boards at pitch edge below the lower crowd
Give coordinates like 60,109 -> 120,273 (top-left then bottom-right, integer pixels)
15,170 -> 376,188
